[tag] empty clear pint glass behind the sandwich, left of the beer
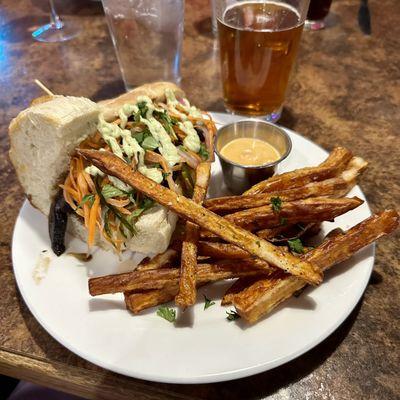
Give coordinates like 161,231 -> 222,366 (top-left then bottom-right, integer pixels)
102,0 -> 185,90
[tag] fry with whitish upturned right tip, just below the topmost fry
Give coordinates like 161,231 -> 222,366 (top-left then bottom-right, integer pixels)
204,157 -> 367,214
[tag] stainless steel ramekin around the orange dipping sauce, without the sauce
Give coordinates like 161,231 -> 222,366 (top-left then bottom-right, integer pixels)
214,119 -> 292,194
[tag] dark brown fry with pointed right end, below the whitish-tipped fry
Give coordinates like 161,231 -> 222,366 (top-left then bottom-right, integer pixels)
225,197 -> 363,231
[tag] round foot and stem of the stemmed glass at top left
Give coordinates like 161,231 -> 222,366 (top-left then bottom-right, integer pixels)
32,0 -> 79,43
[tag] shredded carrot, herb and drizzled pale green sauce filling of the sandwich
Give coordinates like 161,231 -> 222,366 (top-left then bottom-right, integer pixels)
61,89 -> 216,252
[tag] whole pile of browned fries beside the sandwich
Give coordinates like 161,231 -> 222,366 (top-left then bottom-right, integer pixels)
78,147 -> 399,323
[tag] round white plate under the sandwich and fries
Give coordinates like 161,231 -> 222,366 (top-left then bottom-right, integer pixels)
12,113 -> 374,383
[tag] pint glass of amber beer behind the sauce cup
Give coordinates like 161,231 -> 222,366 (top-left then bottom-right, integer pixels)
215,0 -> 309,122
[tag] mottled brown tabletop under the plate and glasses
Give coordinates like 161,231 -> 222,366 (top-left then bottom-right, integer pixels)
0,0 -> 400,400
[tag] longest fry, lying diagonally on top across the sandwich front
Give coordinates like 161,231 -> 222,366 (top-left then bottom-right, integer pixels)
77,150 -> 322,284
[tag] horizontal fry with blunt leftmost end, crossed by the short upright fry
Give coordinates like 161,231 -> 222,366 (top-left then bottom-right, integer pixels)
89,259 -> 276,296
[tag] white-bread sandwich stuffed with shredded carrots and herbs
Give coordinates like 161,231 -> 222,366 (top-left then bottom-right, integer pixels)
9,82 -> 216,254
